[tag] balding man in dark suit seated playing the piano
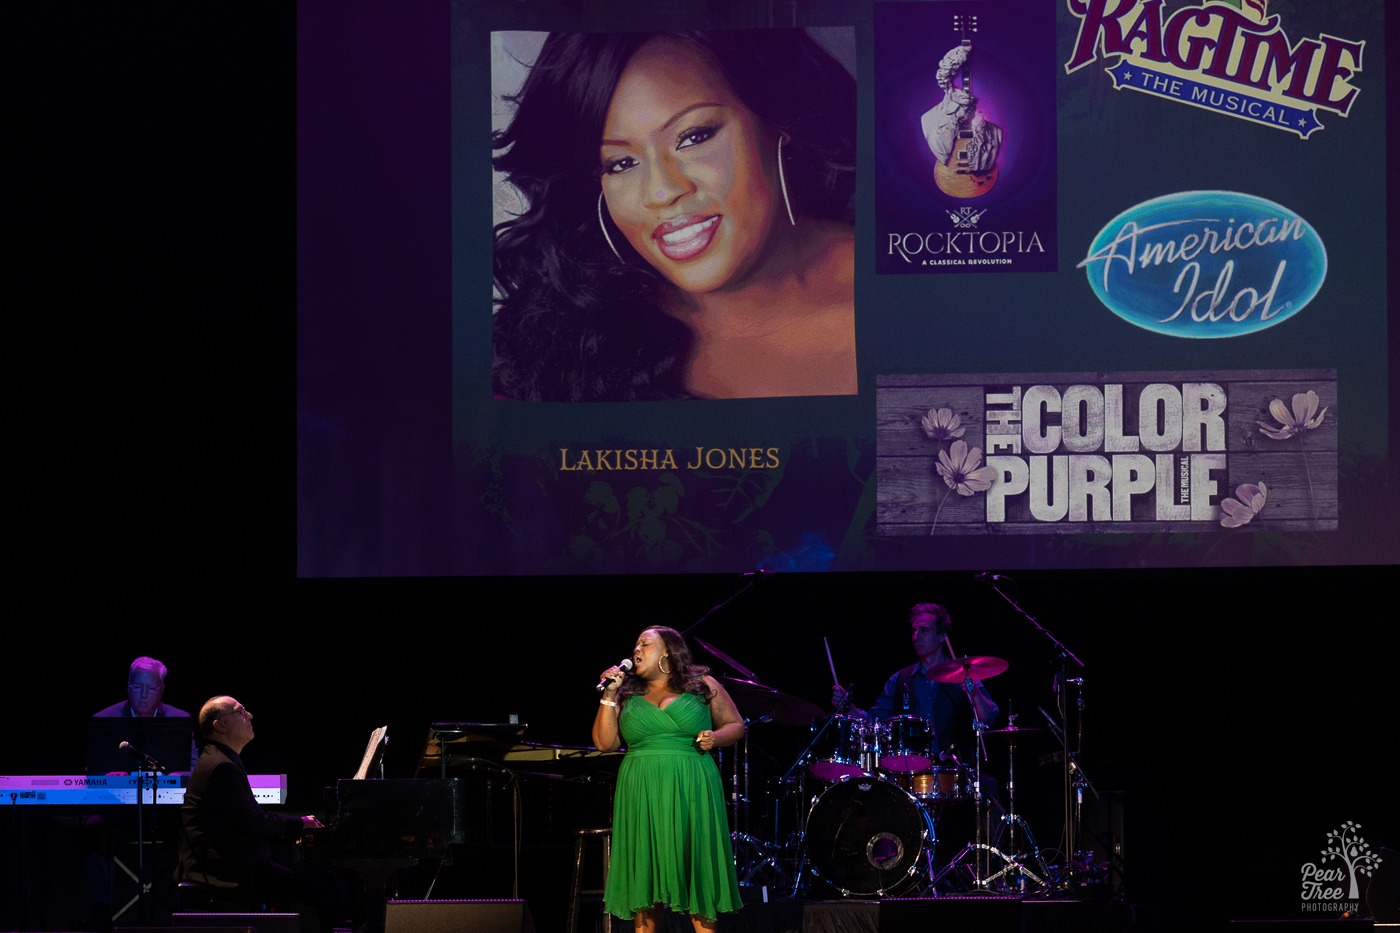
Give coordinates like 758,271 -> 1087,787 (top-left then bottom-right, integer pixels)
178,696 -> 336,933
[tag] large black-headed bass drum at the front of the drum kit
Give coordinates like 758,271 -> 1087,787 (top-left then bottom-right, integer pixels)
806,776 -> 934,897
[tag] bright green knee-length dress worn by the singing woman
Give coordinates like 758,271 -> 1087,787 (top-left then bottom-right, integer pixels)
603,693 -> 742,920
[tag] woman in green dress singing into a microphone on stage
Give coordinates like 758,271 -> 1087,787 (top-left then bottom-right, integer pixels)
594,626 -> 745,933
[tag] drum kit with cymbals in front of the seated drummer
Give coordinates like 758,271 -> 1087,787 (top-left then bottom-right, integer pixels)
721,657 -> 1053,897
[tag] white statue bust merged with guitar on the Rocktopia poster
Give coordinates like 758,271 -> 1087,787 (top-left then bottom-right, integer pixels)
920,15 -> 1002,198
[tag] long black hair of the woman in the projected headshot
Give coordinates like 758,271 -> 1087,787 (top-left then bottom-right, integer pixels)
491,29 -> 855,402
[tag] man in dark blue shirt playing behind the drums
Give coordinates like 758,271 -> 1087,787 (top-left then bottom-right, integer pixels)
832,602 -> 1004,800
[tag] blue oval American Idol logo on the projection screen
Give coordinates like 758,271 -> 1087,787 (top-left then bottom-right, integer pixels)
1078,191 -> 1327,339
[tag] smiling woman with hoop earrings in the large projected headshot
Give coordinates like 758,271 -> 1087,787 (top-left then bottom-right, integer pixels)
491,29 -> 857,402
